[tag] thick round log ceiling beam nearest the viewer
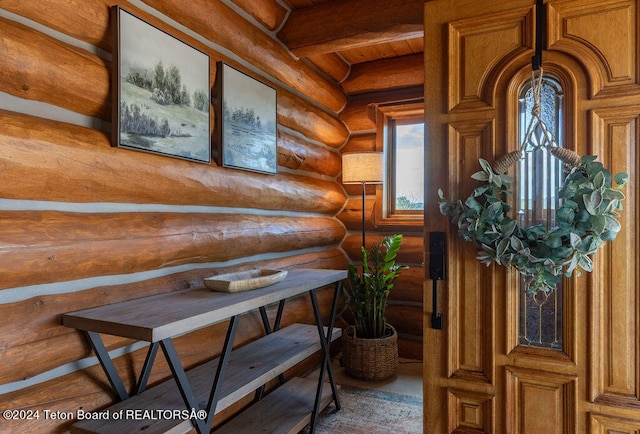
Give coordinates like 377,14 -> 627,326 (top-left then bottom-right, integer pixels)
278,0 -> 424,57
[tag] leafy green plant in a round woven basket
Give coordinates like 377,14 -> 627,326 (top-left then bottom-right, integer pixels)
342,234 -> 407,381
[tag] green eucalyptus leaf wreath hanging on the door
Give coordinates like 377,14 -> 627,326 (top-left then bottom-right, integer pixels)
438,154 -> 628,293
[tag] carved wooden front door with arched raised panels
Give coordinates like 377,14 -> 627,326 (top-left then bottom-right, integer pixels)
424,0 -> 640,434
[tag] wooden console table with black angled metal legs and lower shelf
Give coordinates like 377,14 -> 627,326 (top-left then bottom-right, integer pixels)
63,269 -> 347,434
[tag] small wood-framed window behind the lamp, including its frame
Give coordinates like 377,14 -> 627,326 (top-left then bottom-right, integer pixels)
376,101 -> 424,226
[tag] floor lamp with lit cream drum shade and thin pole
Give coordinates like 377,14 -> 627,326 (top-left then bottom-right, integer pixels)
342,152 -> 384,248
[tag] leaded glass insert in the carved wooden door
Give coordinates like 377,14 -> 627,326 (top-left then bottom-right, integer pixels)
516,75 -> 564,349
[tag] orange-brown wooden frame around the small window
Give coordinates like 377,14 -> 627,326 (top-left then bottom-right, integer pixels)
374,98 -> 424,229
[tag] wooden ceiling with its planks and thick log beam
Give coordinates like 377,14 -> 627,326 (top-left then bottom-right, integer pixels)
277,0 -> 424,95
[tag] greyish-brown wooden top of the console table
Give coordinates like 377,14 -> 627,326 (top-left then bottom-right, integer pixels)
62,269 -> 347,342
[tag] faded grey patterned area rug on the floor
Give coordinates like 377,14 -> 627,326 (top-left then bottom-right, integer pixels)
306,386 -> 422,434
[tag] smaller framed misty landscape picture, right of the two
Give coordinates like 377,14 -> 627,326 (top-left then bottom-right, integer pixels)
216,62 -> 278,175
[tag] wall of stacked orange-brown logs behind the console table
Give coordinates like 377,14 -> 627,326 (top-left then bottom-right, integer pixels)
0,0 -> 349,433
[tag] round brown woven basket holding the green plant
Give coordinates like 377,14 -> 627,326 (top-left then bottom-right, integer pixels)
342,324 -> 398,381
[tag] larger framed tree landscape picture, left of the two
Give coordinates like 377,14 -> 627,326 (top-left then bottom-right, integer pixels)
111,6 -> 211,164
